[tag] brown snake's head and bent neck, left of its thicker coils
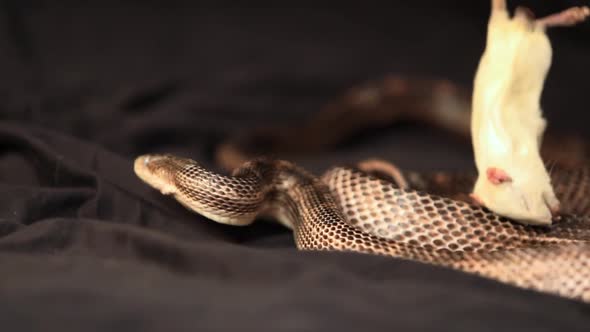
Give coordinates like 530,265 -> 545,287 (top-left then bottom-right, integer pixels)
135,155 -> 344,232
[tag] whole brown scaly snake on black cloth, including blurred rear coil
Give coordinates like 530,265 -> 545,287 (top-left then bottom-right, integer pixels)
134,77 -> 590,302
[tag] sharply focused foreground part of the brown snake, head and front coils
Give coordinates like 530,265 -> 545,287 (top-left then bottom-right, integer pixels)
134,155 -> 590,302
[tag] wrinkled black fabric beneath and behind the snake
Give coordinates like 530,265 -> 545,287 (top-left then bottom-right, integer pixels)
0,0 -> 590,332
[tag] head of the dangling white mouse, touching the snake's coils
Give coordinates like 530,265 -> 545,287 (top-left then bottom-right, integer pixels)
472,165 -> 559,225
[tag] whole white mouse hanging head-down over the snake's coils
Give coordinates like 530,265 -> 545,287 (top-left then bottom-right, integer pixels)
471,0 -> 590,225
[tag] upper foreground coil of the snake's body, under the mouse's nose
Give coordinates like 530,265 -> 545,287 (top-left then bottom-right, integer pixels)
322,168 -> 590,251
